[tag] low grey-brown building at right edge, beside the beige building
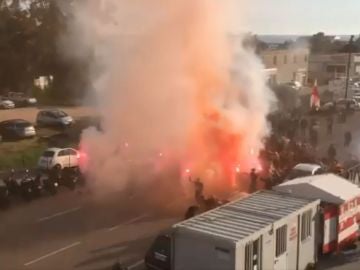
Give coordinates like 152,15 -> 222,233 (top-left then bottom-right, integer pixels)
309,53 -> 360,84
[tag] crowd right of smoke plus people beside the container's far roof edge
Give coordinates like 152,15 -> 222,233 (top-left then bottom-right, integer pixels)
185,109 -> 358,219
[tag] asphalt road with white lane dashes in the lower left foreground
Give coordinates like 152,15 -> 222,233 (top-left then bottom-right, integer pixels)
0,187 -> 186,270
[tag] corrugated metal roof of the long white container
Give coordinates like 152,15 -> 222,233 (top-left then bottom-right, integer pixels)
174,191 -> 313,241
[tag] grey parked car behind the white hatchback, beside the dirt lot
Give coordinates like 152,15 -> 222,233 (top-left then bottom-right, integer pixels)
36,109 -> 74,127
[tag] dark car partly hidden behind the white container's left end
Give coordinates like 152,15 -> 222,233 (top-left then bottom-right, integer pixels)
145,231 -> 172,270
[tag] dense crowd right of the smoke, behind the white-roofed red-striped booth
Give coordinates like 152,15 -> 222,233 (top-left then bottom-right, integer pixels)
258,109 -> 358,190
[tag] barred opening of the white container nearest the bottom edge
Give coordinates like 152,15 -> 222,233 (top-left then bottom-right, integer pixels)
244,237 -> 262,270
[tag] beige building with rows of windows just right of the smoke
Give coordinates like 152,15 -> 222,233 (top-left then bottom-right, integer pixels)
260,48 -> 309,84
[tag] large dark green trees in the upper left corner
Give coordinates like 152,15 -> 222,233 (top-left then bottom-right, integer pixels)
0,0 -> 89,99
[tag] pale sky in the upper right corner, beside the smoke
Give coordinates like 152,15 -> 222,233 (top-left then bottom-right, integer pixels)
230,0 -> 360,35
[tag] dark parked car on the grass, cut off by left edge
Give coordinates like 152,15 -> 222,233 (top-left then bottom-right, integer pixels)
0,119 -> 36,139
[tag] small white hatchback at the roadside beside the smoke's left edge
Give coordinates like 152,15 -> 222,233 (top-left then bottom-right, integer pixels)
38,148 -> 80,170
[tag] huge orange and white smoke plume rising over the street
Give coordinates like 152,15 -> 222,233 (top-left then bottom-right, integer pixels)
62,0 -> 272,194
